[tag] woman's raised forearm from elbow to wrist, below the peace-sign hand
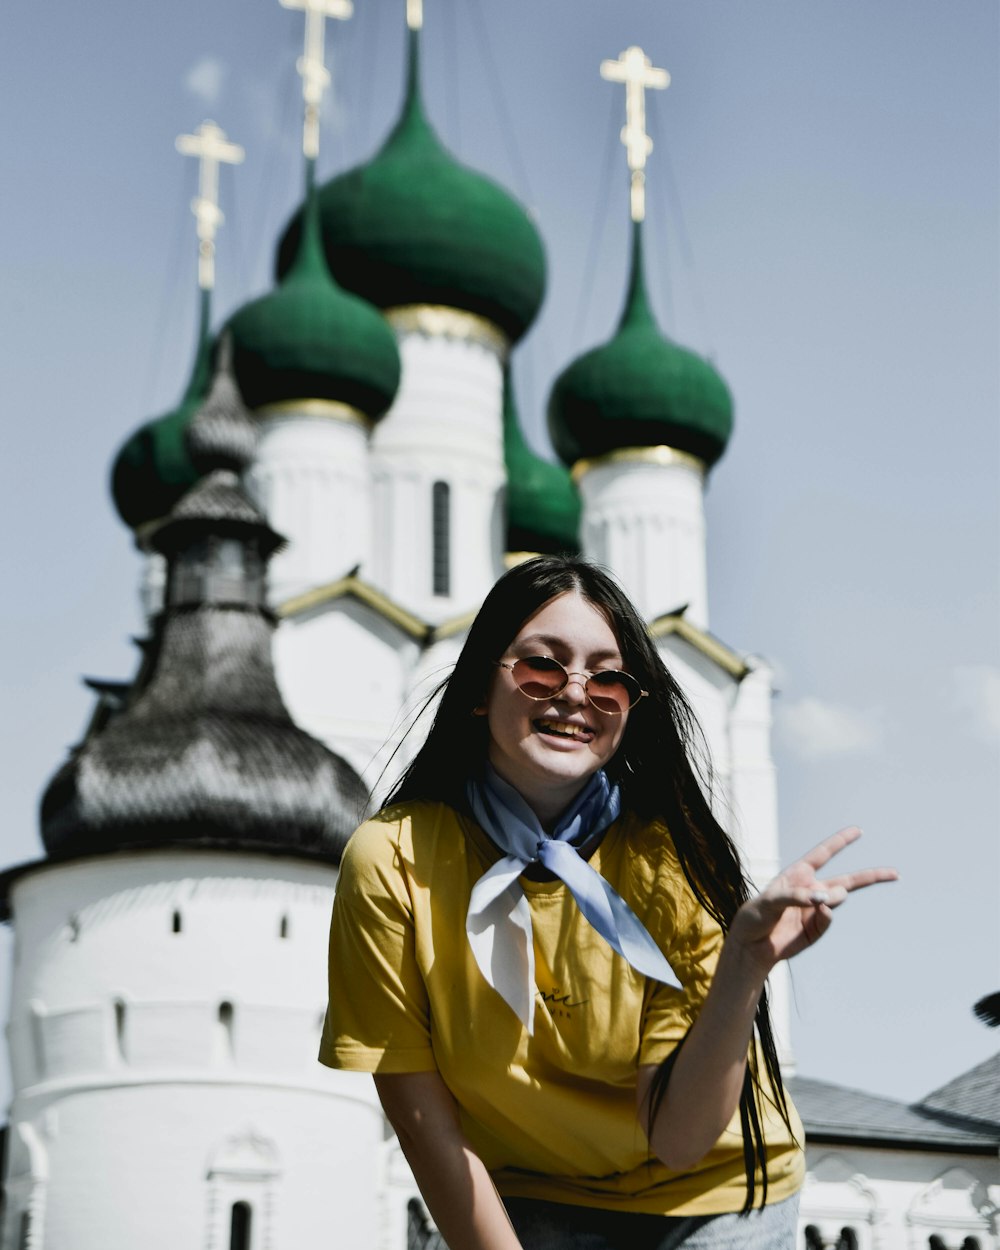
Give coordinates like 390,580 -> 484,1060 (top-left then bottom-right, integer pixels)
639,940 -> 766,1171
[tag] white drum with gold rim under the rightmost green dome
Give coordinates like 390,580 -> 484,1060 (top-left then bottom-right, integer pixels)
574,446 -> 709,629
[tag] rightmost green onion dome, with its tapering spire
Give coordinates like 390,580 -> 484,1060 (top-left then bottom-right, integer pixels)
549,223 -> 733,465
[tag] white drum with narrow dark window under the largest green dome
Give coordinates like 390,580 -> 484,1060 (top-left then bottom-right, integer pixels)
371,306 -> 506,623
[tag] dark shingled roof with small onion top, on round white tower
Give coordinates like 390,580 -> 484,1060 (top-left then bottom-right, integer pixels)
41,350 -> 368,863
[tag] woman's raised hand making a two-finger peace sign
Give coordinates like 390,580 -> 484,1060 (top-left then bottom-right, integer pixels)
729,826 -> 899,973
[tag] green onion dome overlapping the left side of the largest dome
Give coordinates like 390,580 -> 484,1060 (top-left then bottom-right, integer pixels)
228,181 -> 400,420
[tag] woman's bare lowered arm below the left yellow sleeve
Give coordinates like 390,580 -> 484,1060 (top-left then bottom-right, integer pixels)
375,1073 -> 521,1250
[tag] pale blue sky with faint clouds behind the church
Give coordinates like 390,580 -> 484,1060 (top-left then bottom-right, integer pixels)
0,0 -> 1000,1099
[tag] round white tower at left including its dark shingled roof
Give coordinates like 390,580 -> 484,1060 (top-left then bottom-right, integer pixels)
0,345 -> 384,1250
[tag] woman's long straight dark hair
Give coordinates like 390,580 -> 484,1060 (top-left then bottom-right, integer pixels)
386,555 -> 791,1211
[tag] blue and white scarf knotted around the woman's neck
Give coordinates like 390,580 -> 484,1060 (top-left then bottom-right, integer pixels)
465,764 -> 680,1034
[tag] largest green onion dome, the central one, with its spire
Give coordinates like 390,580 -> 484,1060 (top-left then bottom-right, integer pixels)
278,31 -> 545,343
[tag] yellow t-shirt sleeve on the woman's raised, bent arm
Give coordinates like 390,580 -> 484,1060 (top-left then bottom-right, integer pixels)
639,876 -> 723,1065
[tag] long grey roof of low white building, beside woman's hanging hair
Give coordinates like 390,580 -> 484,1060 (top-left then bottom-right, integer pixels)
788,1073 -> 1000,1155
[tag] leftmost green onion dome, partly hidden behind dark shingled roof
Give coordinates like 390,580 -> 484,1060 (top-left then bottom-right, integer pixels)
111,291 -> 213,530
